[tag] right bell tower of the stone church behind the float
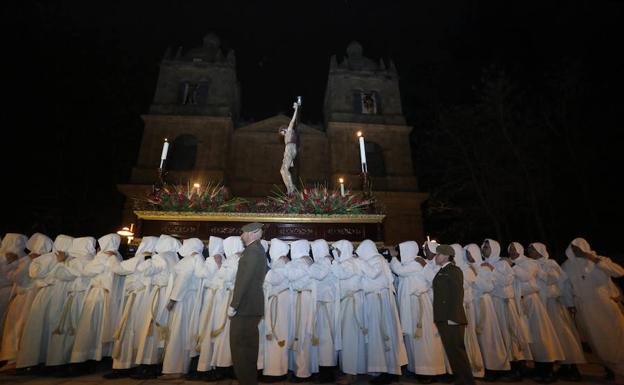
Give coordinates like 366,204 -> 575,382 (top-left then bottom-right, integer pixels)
324,42 -> 427,240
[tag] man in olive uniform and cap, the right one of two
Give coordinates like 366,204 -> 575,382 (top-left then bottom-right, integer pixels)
433,245 -> 475,385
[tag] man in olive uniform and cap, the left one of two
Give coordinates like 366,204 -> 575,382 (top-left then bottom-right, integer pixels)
228,222 -> 266,385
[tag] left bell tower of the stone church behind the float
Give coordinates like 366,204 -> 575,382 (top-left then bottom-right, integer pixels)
131,34 -> 240,184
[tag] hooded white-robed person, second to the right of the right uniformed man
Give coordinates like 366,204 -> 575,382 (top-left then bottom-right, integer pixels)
464,243 -> 511,370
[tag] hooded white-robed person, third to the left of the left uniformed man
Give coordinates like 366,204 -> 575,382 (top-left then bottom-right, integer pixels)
162,238 -> 204,374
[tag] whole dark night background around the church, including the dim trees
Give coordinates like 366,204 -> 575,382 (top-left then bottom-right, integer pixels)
0,0 -> 624,256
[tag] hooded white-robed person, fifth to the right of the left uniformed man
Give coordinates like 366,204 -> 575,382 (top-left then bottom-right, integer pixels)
356,239 -> 408,375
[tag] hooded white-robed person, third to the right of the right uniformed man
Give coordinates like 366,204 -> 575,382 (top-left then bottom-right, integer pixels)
487,239 -> 533,361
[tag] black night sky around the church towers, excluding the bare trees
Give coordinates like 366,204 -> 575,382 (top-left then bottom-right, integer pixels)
0,0 -> 624,252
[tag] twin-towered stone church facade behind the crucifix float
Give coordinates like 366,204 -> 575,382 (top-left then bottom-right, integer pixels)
118,34 -> 427,243
